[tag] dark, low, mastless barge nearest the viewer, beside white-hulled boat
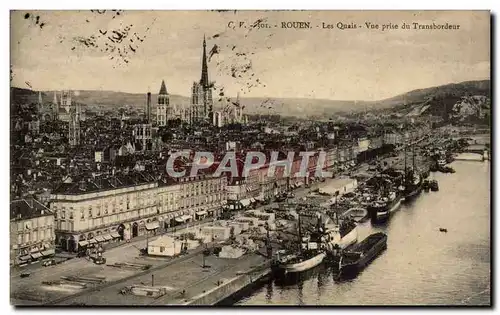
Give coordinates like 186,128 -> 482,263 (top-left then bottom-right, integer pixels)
339,232 -> 387,276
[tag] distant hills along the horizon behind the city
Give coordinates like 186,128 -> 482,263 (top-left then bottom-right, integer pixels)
11,80 -> 491,118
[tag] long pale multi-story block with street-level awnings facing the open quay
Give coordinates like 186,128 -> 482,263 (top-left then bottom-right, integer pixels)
51,172 -> 225,251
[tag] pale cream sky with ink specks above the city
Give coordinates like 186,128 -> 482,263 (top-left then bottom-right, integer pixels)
10,10 -> 490,101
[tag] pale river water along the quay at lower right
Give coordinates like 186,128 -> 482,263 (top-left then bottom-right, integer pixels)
235,161 -> 491,305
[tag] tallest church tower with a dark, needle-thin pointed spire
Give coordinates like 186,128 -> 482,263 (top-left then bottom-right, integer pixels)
190,37 -> 213,124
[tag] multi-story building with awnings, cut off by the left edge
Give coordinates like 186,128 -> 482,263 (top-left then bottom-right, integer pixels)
10,199 -> 55,265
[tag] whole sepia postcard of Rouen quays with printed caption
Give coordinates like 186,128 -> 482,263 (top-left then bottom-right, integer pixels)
10,10 -> 492,306
